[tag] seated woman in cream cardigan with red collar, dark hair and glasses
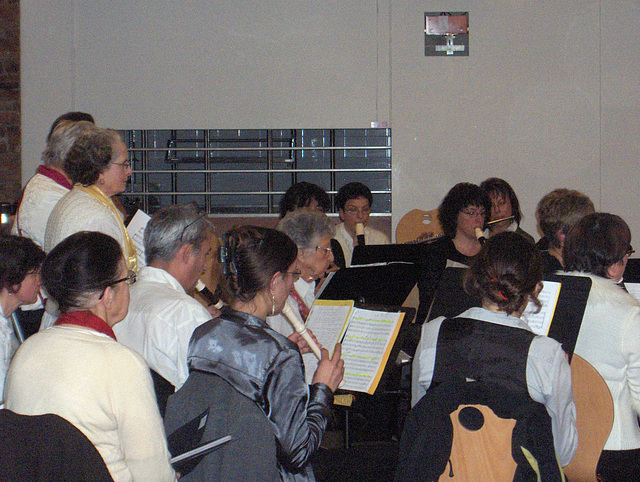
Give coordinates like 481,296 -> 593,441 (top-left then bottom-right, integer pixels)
5,231 -> 176,481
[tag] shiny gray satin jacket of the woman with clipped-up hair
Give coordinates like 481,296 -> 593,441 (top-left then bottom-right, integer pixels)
188,308 -> 333,480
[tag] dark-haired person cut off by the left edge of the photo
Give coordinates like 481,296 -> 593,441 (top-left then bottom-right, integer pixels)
0,236 -> 44,400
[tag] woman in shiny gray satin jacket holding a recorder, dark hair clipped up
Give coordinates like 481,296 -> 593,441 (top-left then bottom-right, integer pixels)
165,226 -> 344,480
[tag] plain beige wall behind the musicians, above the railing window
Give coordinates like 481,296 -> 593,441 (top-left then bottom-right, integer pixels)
21,0 -> 640,245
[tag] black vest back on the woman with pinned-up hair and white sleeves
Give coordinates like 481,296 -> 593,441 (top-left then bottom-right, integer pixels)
432,318 -> 535,394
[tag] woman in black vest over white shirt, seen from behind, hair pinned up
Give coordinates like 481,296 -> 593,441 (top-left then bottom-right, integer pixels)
412,232 -> 578,470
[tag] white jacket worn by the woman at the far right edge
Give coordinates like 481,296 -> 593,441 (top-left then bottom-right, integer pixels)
569,273 -> 640,450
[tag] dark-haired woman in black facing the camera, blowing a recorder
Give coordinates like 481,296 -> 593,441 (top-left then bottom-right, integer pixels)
416,182 -> 491,323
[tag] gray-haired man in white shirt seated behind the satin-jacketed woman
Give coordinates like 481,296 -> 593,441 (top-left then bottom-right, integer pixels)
114,205 -> 215,390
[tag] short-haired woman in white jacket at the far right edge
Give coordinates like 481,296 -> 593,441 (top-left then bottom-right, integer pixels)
563,213 -> 640,482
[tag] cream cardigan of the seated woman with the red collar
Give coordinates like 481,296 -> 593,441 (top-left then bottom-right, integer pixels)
5,325 -> 176,482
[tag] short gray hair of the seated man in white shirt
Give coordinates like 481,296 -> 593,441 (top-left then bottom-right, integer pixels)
144,204 -> 212,264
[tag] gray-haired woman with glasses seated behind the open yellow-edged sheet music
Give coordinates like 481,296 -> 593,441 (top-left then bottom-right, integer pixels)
267,210 -> 334,353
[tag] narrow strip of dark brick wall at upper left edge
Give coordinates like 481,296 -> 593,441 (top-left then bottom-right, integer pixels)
0,0 -> 21,202
